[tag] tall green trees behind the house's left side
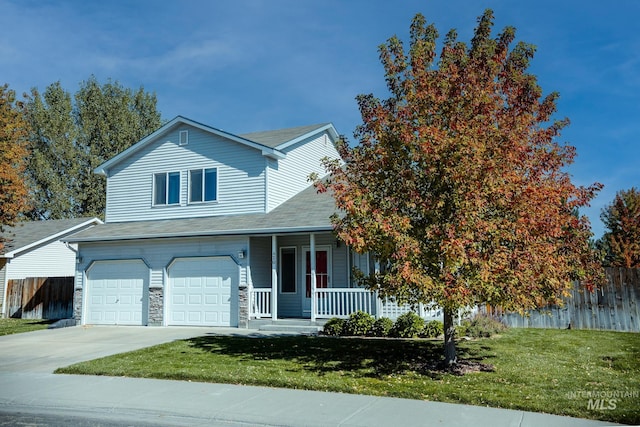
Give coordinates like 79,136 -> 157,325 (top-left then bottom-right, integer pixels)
24,76 -> 161,219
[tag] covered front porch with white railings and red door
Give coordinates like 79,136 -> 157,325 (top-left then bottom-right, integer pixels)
247,232 -> 442,327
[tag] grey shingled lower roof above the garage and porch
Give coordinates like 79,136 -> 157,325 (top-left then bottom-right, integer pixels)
65,186 -> 336,242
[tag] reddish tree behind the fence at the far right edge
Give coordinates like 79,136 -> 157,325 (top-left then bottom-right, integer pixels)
599,187 -> 640,268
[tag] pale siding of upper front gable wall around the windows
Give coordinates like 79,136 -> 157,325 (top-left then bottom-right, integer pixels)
106,125 -> 266,222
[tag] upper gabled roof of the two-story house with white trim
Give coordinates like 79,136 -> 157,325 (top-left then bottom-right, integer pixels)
94,116 -> 338,175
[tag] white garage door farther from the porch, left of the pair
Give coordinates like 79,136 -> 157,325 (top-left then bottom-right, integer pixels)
84,260 -> 149,325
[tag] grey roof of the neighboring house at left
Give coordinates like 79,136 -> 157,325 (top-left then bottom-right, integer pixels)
0,218 -> 102,258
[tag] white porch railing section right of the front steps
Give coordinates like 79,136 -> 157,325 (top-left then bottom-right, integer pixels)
315,288 -> 377,319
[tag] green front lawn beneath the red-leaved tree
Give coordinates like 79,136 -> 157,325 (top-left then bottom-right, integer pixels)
56,329 -> 640,424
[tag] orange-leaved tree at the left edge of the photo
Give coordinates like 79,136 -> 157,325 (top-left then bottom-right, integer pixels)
0,85 -> 28,248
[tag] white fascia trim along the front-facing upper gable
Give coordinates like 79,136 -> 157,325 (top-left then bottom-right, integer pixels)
93,116 -> 286,176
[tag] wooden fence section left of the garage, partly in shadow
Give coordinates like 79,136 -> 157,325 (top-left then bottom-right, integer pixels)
7,277 -> 73,319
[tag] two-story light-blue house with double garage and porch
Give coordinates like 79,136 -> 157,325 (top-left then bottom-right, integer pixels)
67,117 -> 392,327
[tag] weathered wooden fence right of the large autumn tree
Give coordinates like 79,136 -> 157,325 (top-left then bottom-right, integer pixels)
484,267 -> 640,332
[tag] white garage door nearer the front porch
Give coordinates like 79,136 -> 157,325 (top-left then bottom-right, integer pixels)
167,256 -> 239,326
